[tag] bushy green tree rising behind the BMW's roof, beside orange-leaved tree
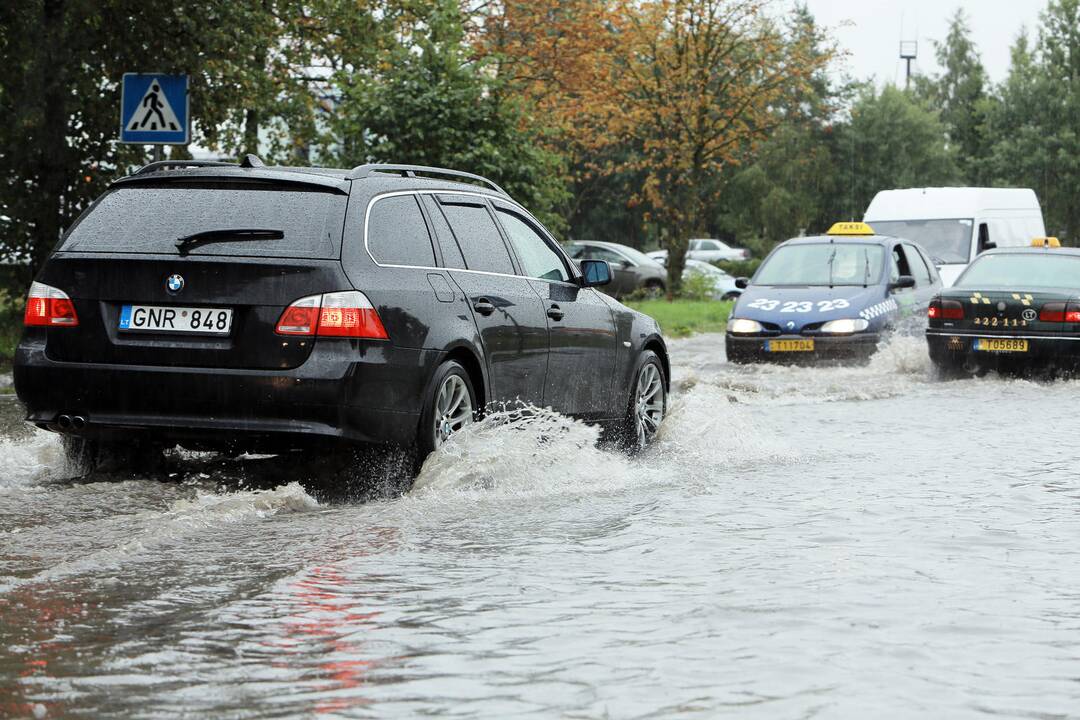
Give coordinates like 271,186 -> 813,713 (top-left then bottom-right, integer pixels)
327,0 -> 567,231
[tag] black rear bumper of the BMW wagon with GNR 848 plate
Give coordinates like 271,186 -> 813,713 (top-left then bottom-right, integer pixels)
14,338 -> 441,449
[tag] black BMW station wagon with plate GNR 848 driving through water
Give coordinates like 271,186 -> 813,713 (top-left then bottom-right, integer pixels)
14,155 -> 670,472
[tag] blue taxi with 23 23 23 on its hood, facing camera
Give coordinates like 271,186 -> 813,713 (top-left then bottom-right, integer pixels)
726,222 -> 942,363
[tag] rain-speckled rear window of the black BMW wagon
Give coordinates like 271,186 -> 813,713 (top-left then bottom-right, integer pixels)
60,182 -> 348,259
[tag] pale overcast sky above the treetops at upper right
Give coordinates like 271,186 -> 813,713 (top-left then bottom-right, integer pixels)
807,0 -> 1047,84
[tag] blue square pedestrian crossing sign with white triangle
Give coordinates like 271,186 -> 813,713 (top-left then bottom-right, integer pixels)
120,72 -> 191,145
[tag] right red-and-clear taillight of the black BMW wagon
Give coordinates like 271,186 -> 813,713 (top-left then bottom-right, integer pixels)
275,290 -> 389,340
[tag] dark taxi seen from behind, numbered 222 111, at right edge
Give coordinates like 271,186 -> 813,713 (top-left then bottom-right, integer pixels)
927,237 -> 1080,373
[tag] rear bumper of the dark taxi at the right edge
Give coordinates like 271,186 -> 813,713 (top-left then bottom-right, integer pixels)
927,329 -> 1080,368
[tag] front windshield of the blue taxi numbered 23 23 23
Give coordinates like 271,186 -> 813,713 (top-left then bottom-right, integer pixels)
754,243 -> 885,287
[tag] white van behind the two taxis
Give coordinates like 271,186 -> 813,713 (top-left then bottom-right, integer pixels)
863,188 -> 1047,287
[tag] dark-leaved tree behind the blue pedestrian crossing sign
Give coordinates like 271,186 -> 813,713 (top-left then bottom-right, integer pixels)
0,0 -> 291,281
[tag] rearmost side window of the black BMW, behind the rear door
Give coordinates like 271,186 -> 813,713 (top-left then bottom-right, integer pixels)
367,195 -> 435,268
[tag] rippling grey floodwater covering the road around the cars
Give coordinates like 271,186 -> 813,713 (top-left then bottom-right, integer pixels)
0,336 -> 1080,718
